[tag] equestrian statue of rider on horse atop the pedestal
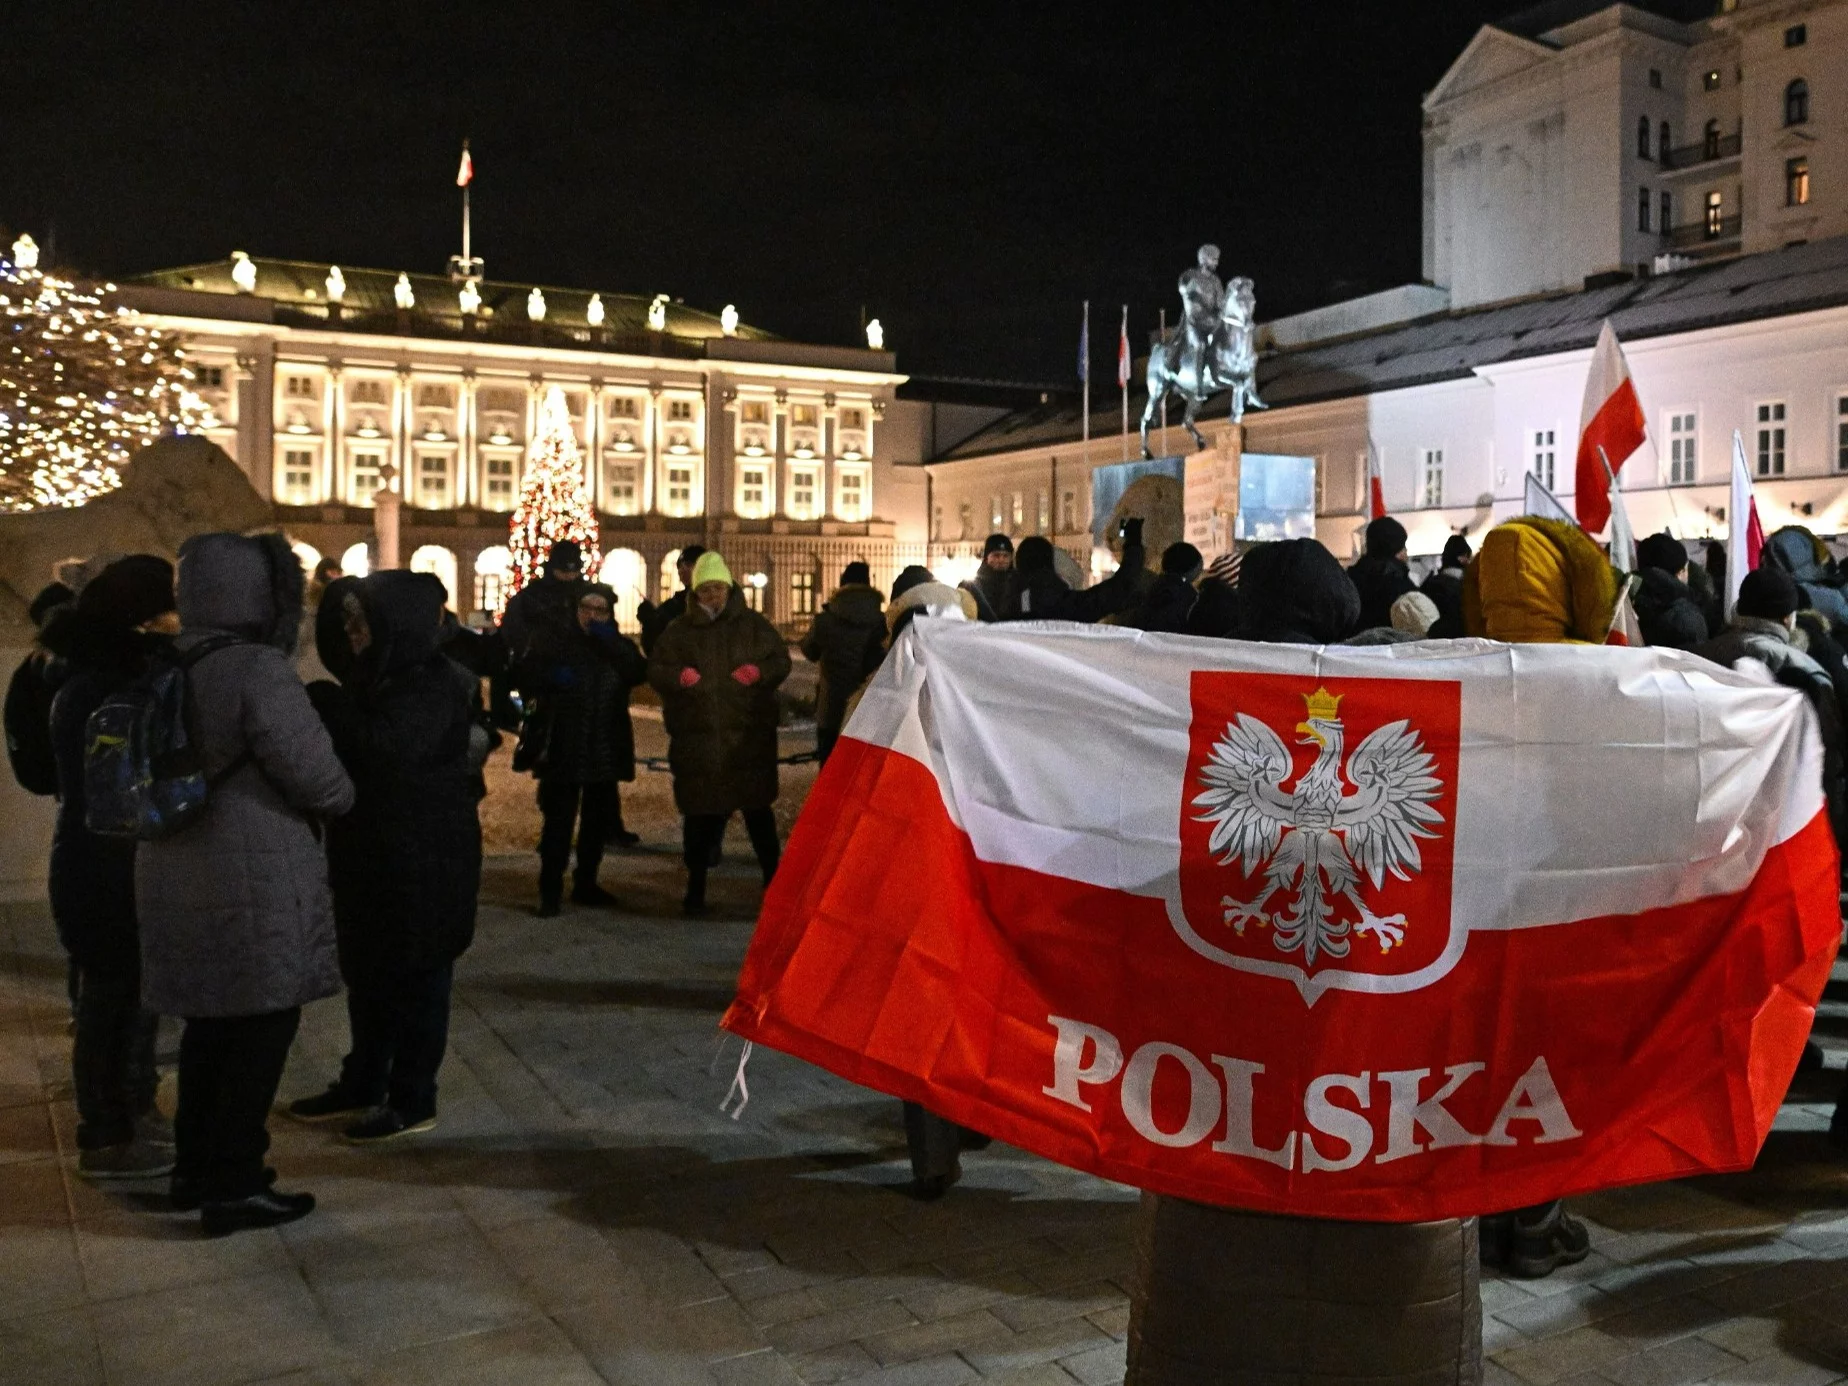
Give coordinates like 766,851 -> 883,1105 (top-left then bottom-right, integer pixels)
1142,246 -> 1266,456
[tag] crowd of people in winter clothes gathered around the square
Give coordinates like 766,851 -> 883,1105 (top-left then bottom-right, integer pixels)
6,516 -> 1848,1275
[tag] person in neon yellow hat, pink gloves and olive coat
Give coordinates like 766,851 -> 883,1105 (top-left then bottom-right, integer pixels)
649,553 -> 789,915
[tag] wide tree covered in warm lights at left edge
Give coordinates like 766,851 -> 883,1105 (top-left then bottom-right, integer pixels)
0,237 -> 216,512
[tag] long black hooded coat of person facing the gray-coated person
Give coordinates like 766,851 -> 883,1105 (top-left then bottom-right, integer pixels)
321,571 -> 480,983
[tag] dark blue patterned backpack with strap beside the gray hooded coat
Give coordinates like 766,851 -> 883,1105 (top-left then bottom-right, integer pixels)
83,636 -> 249,843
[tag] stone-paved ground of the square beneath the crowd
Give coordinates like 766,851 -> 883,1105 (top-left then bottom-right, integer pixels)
0,848 -> 1848,1386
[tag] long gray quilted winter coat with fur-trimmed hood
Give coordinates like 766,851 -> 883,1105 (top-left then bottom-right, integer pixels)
135,534 -> 353,1016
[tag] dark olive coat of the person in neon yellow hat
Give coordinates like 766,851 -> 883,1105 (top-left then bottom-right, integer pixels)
649,588 -> 789,815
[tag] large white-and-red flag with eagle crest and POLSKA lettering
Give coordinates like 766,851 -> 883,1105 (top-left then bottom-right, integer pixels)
724,619 -> 1841,1222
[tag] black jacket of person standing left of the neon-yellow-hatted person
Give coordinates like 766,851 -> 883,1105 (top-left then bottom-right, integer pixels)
519,617 -> 649,784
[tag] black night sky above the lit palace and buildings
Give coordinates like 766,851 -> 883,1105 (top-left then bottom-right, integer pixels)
0,0 -> 1517,384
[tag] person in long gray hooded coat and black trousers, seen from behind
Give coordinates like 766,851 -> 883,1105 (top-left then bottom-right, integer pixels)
135,534 -> 353,1234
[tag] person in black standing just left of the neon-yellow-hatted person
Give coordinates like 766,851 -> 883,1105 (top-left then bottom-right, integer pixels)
514,582 -> 647,918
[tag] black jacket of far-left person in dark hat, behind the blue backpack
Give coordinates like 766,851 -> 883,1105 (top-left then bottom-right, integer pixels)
46,610 -> 163,972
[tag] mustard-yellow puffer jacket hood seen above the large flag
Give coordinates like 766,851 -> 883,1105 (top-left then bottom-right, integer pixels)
1464,516 -> 1617,645
